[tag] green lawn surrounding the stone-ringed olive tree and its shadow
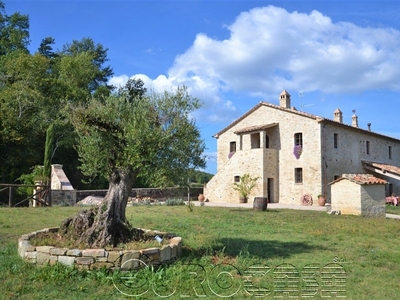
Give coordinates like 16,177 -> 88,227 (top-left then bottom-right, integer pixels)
0,205 -> 400,299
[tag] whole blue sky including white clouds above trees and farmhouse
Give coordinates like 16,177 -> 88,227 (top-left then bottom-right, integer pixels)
4,0 -> 400,173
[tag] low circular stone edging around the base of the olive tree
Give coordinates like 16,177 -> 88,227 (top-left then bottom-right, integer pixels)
18,227 -> 182,271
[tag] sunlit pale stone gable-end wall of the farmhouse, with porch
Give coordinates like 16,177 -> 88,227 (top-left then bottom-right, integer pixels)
205,104 -> 322,205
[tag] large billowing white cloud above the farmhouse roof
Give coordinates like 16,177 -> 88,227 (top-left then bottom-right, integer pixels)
111,6 -> 400,122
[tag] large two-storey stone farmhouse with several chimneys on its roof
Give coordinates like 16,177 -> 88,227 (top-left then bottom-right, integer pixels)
204,90 -> 400,205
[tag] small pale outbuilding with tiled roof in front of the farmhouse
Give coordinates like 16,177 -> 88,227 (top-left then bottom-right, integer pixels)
330,174 -> 387,217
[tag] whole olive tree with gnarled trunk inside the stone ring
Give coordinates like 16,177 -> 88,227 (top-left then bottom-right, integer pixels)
61,87 -> 205,247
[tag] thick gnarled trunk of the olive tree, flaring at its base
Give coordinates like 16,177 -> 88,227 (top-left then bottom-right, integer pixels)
60,168 -> 136,248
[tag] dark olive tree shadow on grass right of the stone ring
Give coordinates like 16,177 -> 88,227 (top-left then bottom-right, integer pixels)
184,238 -> 326,259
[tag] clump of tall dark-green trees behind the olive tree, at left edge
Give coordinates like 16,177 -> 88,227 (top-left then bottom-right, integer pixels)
0,0 -> 112,185
